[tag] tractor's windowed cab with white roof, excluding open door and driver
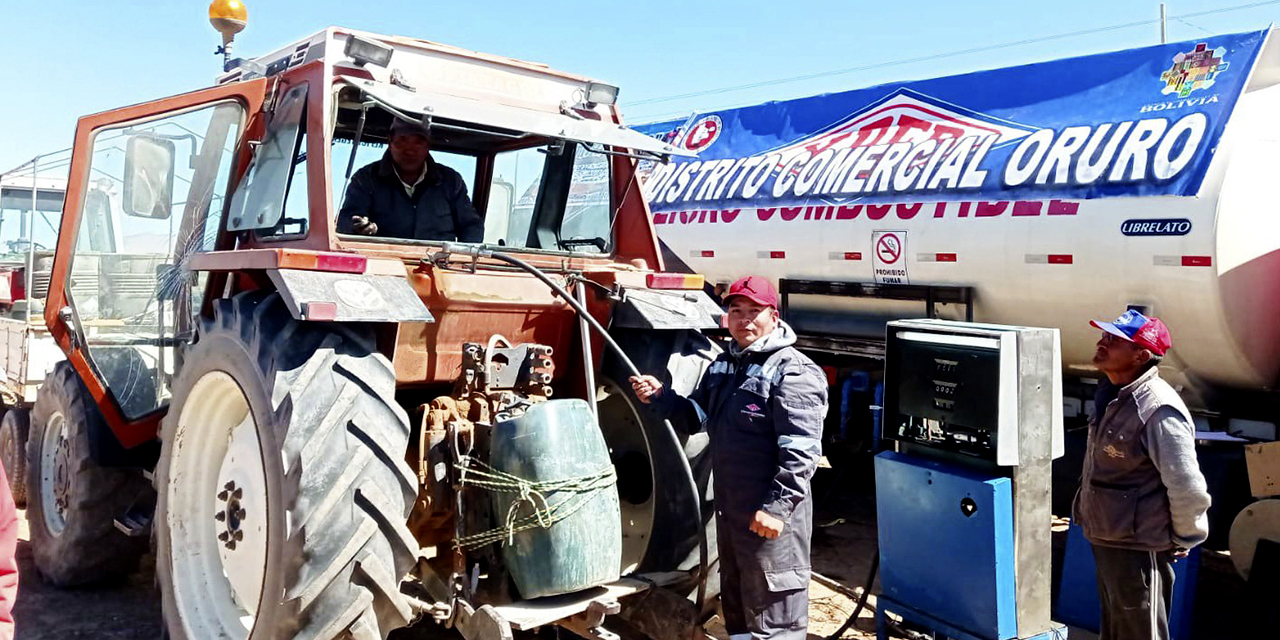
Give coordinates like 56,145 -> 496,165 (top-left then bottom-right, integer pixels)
221,29 -> 677,254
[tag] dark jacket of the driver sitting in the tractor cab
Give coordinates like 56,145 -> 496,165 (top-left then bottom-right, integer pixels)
338,151 -> 484,242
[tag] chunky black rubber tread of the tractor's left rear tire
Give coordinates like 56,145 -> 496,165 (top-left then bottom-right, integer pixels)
154,292 -> 417,640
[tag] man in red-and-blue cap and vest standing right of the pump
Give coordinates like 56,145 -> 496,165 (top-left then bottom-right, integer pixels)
1071,310 -> 1210,640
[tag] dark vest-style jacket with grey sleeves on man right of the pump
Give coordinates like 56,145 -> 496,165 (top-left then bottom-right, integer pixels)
1073,367 -> 1210,552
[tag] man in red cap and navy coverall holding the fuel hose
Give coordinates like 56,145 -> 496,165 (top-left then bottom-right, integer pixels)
631,275 -> 827,640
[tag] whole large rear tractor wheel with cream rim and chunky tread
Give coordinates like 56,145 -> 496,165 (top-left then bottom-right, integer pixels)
155,292 -> 417,640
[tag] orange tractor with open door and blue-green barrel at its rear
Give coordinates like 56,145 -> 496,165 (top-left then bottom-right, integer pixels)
26,20 -> 721,640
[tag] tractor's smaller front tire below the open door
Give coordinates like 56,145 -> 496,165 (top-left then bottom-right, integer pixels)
24,362 -> 151,588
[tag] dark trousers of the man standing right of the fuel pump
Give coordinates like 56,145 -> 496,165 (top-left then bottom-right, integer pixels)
1093,544 -> 1174,640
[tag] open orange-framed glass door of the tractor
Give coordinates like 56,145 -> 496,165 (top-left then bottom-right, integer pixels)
45,79 -> 266,447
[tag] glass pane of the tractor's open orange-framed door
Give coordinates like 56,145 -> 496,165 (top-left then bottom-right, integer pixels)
60,101 -> 244,420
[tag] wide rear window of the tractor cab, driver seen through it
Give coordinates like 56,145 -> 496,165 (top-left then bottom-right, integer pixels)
332,96 -> 613,253
